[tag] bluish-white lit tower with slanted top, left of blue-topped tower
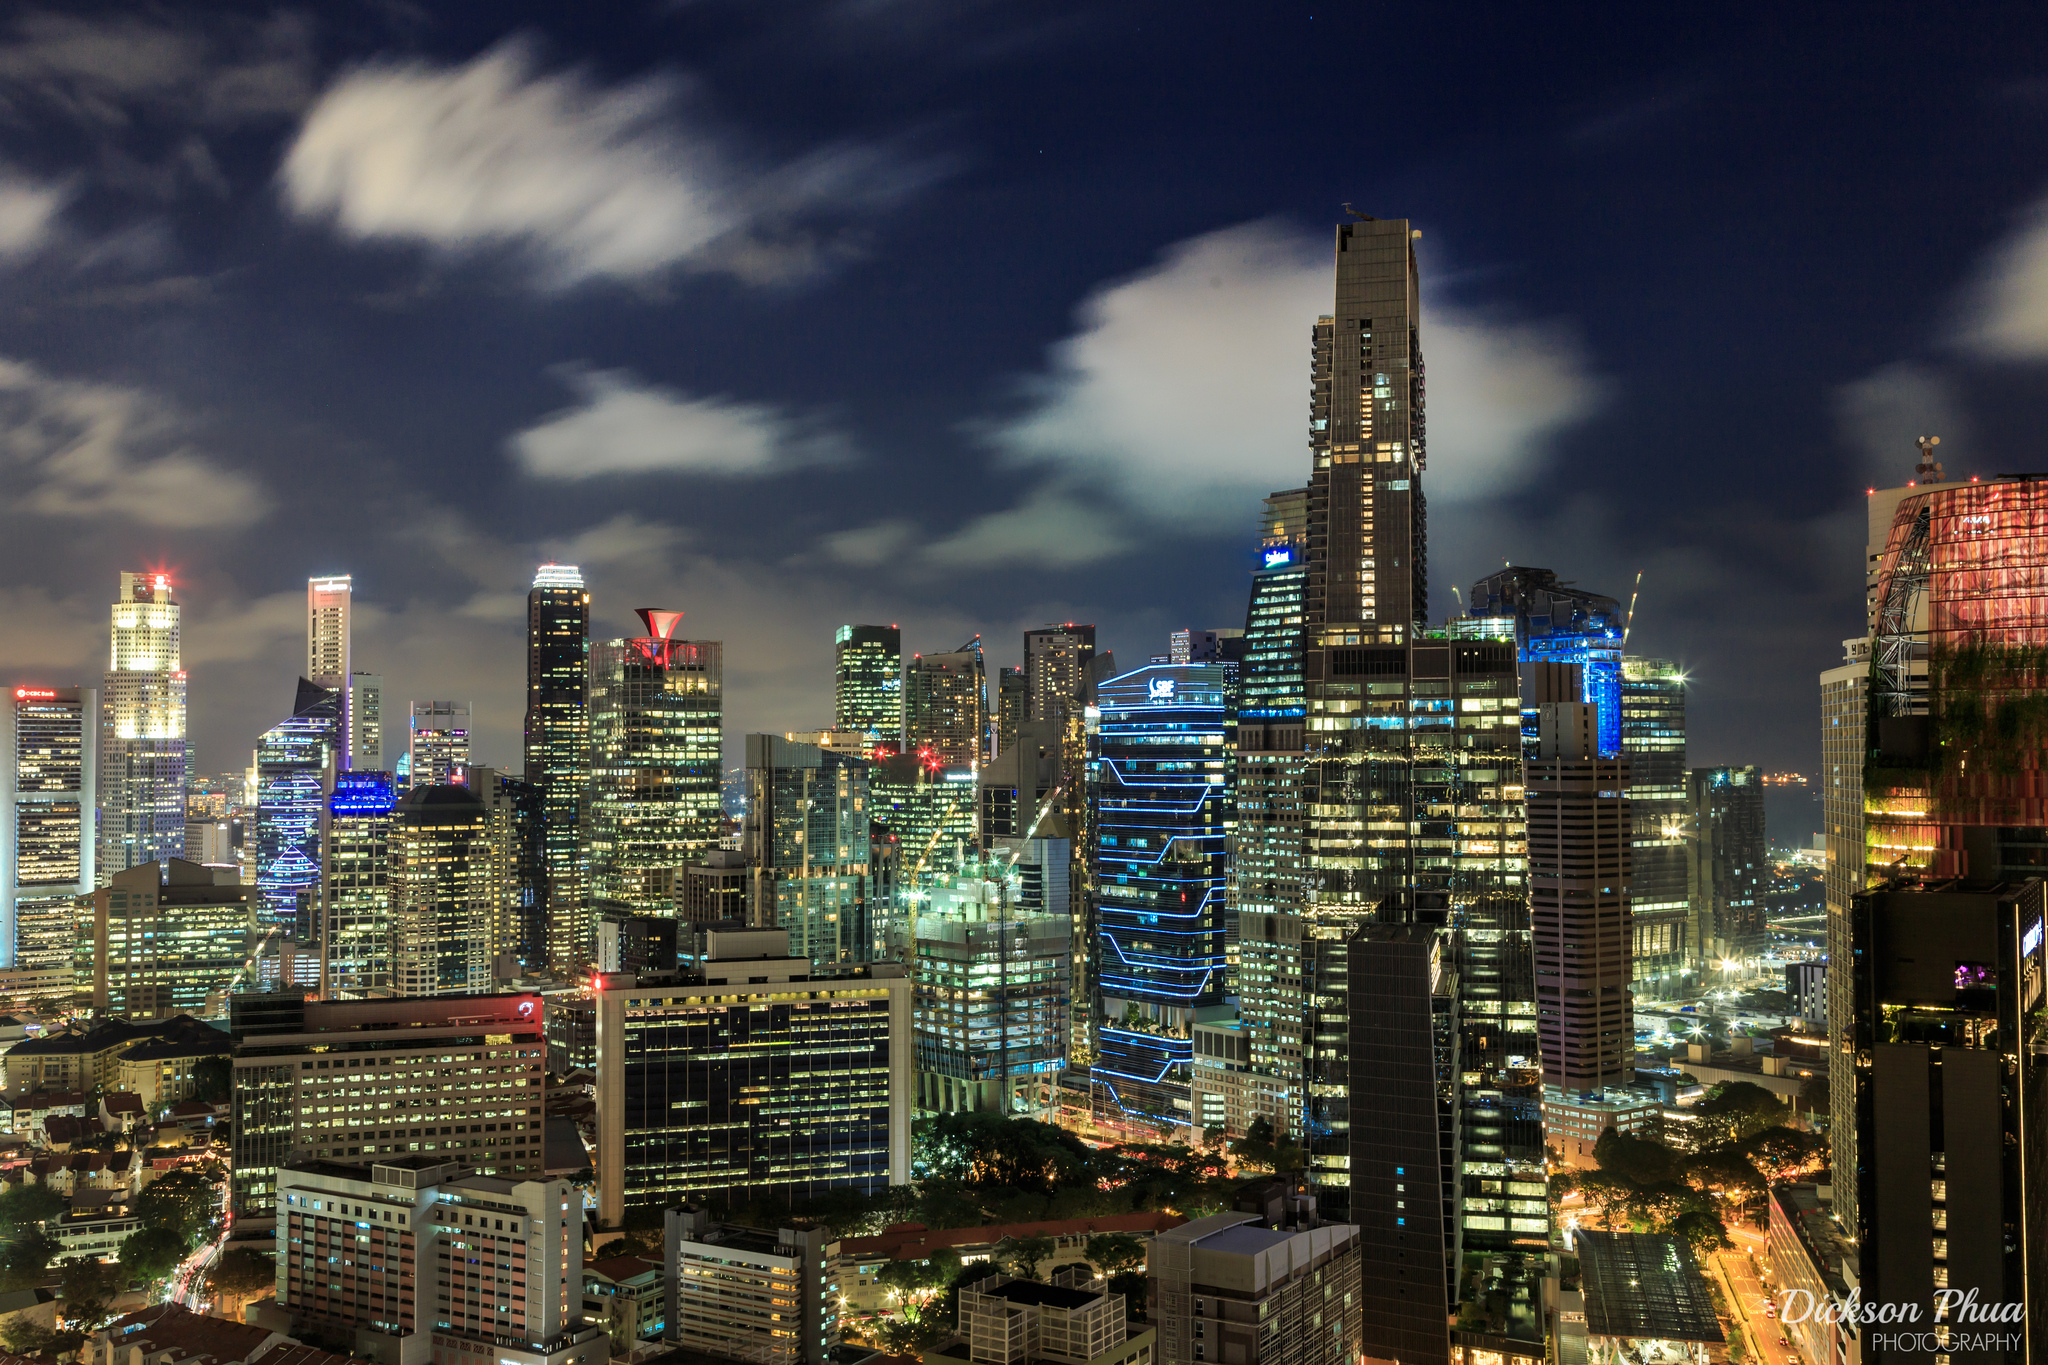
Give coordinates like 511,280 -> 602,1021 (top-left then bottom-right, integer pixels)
256,677 -> 342,937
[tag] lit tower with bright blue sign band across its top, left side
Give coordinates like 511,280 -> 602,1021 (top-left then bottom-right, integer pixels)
319,772 -> 397,999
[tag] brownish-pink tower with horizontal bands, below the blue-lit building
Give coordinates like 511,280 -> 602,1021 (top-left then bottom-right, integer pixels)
1528,695 -> 1636,1126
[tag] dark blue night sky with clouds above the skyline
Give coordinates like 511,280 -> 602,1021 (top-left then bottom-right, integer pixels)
0,0 -> 2048,774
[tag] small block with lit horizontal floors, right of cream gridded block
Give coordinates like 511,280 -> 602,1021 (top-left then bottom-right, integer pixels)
662,1205 -> 840,1365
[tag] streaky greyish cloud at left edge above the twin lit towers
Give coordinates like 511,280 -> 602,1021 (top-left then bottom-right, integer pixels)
0,360 -> 270,530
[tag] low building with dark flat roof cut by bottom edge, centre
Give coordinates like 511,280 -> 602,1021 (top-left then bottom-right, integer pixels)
924,1273 -> 1155,1365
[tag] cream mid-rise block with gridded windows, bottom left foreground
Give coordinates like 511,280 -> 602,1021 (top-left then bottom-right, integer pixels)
276,1156 -> 608,1365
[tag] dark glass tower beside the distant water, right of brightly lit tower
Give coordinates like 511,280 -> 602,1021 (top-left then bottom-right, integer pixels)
1686,763 -> 1772,970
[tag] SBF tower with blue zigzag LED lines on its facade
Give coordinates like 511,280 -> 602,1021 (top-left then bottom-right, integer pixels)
1094,663 -> 1235,1124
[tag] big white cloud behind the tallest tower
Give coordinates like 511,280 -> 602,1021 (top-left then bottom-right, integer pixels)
987,223 -> 1602,522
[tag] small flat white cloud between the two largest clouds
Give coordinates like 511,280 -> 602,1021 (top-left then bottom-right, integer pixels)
510,368 -> 850,479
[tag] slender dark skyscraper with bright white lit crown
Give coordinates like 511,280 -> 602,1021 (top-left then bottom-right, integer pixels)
526,565 -> 594,968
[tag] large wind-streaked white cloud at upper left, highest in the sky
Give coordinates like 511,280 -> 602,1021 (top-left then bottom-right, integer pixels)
281,43 -> 930,284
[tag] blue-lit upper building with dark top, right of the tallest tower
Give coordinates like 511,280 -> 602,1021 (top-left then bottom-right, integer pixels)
1470,565 -> 1622,759
